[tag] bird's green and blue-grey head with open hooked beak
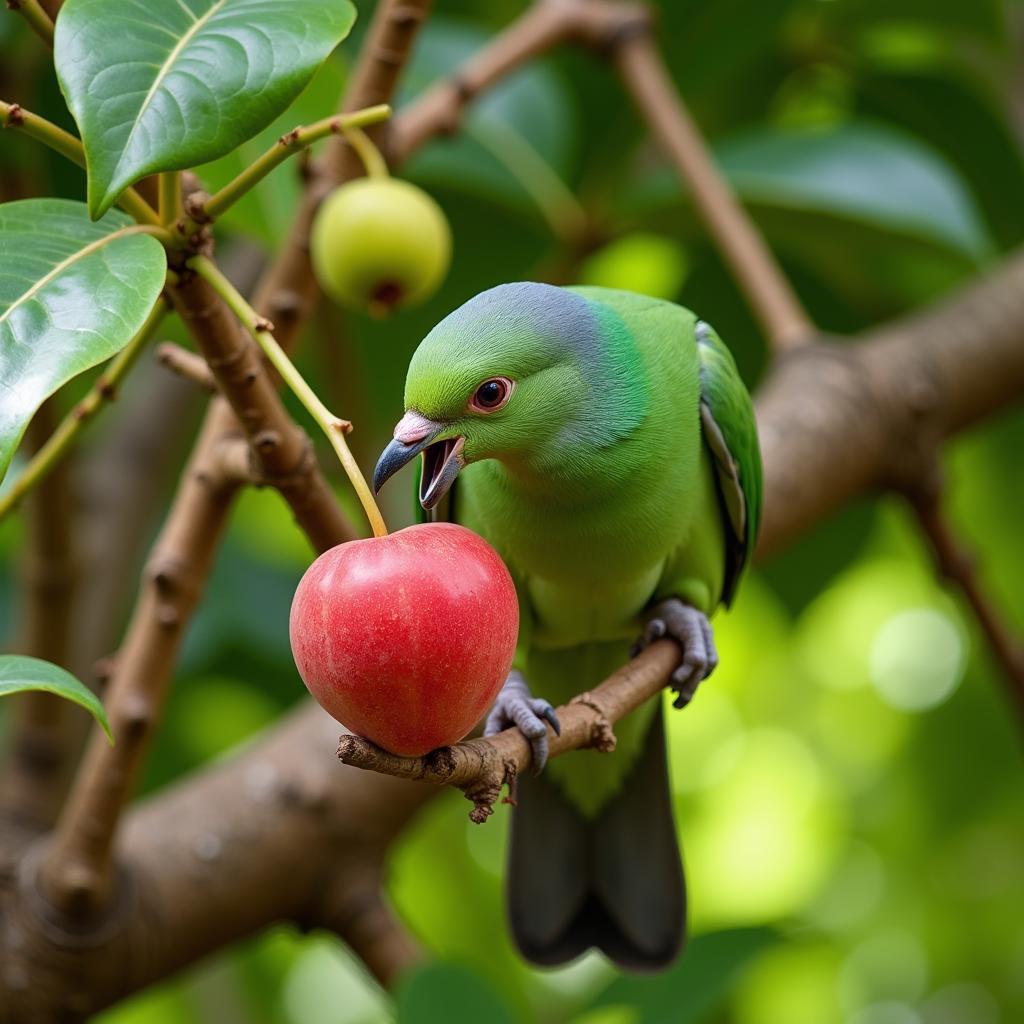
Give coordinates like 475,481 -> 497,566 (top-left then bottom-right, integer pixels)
374,283 -> 635,509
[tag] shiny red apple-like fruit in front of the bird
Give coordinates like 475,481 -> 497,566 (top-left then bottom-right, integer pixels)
290,523 -> 519,757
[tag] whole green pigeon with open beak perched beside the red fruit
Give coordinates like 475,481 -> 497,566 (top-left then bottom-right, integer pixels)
374,282 -> 762,970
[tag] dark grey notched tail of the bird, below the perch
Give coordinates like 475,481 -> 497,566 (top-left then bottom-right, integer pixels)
508,708 -> 686,971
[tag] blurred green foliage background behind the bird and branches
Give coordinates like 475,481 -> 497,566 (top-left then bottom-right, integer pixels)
0,0 -> 1024,1024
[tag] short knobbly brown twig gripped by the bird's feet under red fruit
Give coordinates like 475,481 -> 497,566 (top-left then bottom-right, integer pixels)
338,640 -> 679,823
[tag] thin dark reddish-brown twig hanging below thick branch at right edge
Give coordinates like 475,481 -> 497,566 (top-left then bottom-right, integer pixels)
907,472 -> 1024,725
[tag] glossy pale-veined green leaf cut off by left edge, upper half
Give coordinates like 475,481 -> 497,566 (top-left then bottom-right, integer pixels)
0,199 -> 167,478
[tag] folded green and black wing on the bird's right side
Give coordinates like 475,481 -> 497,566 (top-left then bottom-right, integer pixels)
694,321 -> 764,607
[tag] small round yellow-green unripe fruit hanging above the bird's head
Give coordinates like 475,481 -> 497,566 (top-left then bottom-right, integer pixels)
311,177 -> 452,312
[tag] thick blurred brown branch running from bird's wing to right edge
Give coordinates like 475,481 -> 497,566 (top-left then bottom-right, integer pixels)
757,253 -> 1024,555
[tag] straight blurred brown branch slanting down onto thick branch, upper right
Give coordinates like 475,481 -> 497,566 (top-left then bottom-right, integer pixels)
613,33 -> 817,351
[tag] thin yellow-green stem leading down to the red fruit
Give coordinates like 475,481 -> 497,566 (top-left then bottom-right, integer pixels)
186,256 -> 387,537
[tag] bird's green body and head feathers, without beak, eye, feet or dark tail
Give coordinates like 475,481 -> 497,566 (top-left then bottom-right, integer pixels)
397,284 -> 762,958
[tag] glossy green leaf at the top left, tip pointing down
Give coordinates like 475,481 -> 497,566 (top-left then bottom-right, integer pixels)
54,0 -> 355,217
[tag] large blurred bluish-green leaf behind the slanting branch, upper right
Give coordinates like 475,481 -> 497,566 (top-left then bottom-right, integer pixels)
620,121 -> 993,316
